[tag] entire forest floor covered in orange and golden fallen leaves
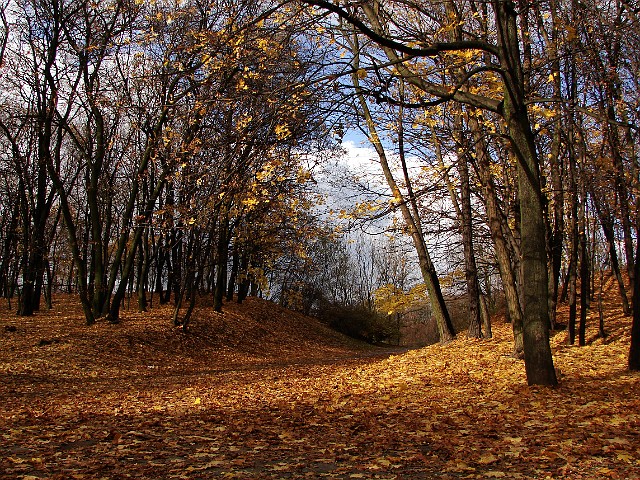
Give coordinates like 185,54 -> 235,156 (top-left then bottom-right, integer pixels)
0,280 -> 640,480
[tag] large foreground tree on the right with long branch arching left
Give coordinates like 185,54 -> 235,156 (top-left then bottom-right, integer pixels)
306,0 -> 557,385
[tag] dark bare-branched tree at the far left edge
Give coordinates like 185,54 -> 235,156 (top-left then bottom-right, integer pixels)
0,1 -> 67,316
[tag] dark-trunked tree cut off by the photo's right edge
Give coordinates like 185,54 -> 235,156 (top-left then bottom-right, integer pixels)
574,2 -> 640,370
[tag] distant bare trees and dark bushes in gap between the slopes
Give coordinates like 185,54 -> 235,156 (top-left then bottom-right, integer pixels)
288,233 -> 418,343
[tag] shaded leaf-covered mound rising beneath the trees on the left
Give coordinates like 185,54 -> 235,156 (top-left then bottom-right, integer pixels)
0,296 -> 380,377
